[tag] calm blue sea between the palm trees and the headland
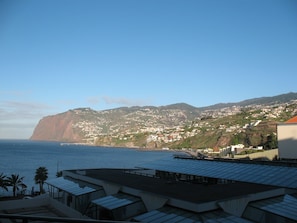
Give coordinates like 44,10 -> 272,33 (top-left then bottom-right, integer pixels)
0,140 -> 173,195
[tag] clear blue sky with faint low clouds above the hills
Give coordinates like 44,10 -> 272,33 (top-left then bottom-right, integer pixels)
0,0 -> 297,139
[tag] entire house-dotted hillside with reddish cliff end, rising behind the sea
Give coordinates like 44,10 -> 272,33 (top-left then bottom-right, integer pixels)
30,93 -> 297,149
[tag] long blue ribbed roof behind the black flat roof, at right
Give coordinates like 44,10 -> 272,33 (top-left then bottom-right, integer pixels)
139,158 -> 297,189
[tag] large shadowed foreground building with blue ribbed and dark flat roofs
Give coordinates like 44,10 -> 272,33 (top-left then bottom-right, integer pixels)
0,156 -> 297,223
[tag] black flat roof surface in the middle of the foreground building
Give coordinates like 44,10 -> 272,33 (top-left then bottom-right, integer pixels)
69,169 -> 276,203
